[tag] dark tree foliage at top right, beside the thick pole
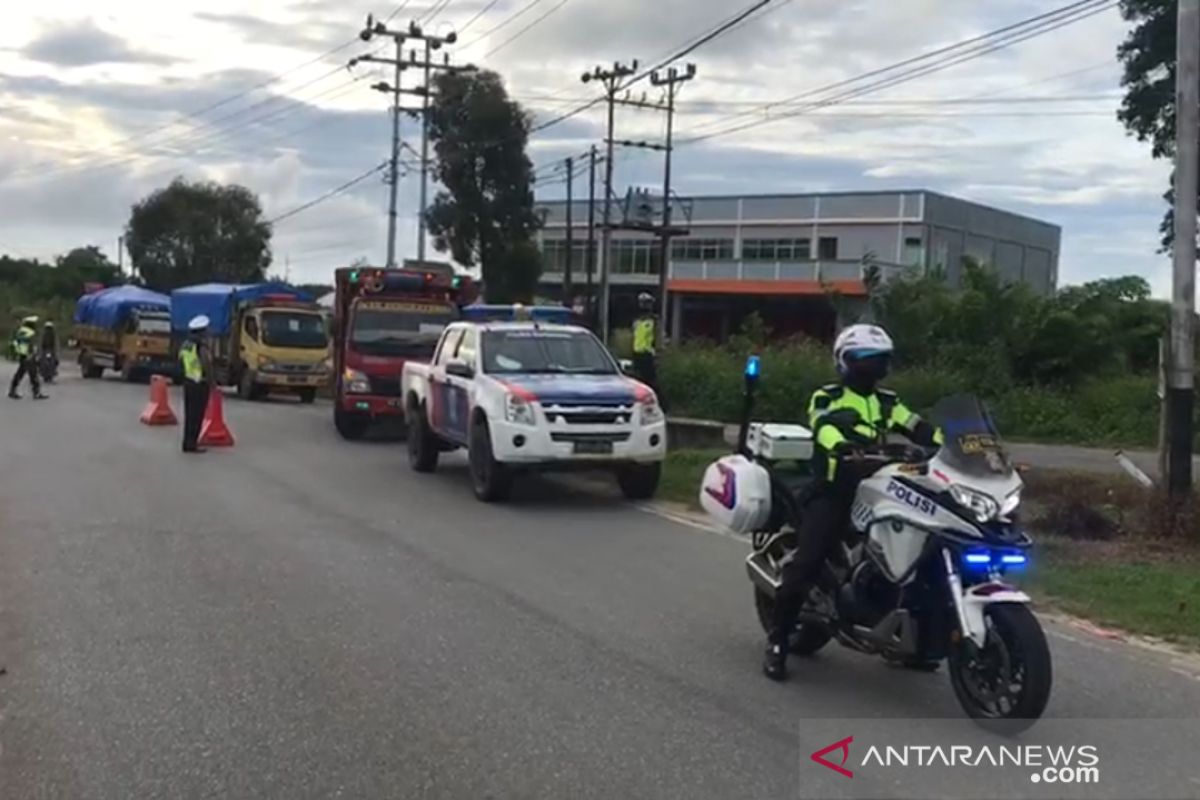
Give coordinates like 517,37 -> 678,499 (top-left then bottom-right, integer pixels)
1117,0 -> 1195,251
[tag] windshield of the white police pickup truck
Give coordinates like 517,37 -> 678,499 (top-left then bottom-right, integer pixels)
484,330 -> 617,375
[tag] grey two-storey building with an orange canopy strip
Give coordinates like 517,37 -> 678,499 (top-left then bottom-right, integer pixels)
538,190 -> 1062,341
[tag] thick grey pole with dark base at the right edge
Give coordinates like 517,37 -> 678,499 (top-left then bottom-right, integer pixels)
1165,0 -> 1200,499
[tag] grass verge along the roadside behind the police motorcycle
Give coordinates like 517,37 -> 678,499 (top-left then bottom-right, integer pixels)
659,450 -> 1200,648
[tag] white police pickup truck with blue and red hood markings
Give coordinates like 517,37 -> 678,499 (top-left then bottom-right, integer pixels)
401,311 -> 667,503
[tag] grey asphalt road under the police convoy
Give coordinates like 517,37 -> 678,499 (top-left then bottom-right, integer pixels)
0,377 -> 1200,800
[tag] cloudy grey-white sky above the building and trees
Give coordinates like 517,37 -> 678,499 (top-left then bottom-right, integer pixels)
0,0 -> 1169,294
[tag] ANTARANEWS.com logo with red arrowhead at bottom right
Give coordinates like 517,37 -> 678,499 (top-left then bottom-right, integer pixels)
810,736 -> 1100,783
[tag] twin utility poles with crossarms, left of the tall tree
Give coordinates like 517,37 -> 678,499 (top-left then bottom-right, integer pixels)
348,14 -> 475,266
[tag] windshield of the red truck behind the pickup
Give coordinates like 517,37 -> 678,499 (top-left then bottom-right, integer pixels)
350,302 -> 457,360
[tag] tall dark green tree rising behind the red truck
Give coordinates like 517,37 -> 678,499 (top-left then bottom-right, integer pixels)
426,71 -> 541,302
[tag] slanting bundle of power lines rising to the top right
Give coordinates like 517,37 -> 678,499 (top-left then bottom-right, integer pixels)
680,0 -> 1117,145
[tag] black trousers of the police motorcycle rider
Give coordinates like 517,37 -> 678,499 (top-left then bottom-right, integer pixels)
770,477 -> 858,648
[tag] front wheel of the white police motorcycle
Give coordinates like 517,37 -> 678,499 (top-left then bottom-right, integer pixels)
949,603 -> 1052,734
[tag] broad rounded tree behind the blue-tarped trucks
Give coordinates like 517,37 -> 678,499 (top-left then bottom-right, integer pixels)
125,178 -> 271,290
